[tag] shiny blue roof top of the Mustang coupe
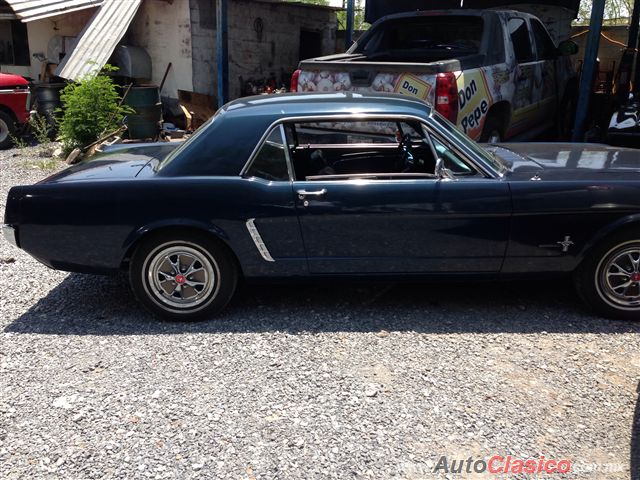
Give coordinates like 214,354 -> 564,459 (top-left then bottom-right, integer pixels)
223,92 -> 431,119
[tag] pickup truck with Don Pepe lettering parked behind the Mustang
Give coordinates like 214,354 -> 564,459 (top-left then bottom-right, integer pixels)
291,10 -> 577,142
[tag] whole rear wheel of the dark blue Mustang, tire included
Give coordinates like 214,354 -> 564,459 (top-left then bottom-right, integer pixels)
129,232 -> 238,321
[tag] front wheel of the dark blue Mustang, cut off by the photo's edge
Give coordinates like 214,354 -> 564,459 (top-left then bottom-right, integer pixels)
574,230 -> 640,320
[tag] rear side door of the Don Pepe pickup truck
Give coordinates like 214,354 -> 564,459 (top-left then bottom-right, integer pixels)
507,17 -> 541,137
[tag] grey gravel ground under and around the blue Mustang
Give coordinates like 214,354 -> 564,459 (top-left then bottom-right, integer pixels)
0,150 -> 640,480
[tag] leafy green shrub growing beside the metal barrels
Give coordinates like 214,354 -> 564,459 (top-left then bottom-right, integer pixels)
58,65 -> 133,152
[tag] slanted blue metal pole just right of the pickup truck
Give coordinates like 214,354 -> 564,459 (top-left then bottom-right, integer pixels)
573,0 -> 605,142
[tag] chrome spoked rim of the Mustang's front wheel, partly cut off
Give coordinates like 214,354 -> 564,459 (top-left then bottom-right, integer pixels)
598,242 -> 640,310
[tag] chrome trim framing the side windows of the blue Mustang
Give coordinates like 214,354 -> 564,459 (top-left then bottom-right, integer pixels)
240,113 -> 503,182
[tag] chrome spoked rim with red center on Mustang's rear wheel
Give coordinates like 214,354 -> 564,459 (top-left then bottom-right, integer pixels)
144,244 -> 219,310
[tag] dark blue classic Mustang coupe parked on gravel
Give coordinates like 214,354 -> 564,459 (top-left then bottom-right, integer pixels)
4,94 -> 640,320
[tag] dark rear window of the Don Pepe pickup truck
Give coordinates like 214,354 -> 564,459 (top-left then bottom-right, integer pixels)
357,15 -> 483,55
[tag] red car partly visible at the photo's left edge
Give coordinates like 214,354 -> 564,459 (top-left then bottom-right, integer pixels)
0,73 -> 31,149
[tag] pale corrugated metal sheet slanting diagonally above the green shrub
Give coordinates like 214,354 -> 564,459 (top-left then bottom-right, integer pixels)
56,0 -> 142,80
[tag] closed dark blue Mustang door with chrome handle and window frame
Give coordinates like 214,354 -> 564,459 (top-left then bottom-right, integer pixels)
284,116 -> 511,274
